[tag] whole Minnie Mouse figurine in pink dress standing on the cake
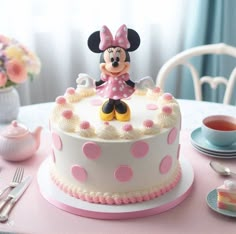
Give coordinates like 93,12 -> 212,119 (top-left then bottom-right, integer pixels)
88,25 -> 140,121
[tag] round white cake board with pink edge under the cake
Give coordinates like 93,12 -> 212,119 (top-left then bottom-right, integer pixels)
37,157 -> 194,219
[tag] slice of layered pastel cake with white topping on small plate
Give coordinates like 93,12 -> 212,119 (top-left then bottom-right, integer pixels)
217,180 -> 236,211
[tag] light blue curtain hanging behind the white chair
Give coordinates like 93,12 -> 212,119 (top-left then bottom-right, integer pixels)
179,0 -> 236,105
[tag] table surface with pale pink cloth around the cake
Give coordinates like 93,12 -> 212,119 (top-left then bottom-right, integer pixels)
0,100 -> 236,234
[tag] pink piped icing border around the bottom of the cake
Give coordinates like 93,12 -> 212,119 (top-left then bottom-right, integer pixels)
50,165 -> 182,205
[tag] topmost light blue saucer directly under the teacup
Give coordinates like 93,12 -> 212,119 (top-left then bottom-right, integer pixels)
191,127 -> 236,154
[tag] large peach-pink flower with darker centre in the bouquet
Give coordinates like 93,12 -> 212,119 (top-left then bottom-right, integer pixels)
6,59 -> 27,83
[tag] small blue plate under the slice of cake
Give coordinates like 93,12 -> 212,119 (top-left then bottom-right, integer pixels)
206,189 -> 236,218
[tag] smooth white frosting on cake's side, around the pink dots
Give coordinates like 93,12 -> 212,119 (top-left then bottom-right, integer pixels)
50,124 -> 179,194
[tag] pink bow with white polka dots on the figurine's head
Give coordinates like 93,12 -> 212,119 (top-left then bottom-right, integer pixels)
99,24 -> 130,50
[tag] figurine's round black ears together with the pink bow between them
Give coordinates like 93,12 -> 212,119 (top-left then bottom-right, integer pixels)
88,24 -> 140,53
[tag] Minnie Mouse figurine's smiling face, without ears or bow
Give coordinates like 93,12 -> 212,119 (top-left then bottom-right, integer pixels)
100,47 -> 130,76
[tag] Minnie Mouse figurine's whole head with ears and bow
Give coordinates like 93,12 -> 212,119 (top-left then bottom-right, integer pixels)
88,25 -> 140,76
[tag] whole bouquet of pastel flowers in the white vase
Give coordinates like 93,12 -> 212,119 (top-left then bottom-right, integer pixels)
0,35 -> 41,89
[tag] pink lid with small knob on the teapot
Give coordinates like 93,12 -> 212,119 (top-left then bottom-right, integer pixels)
0,120 -> 28,138
